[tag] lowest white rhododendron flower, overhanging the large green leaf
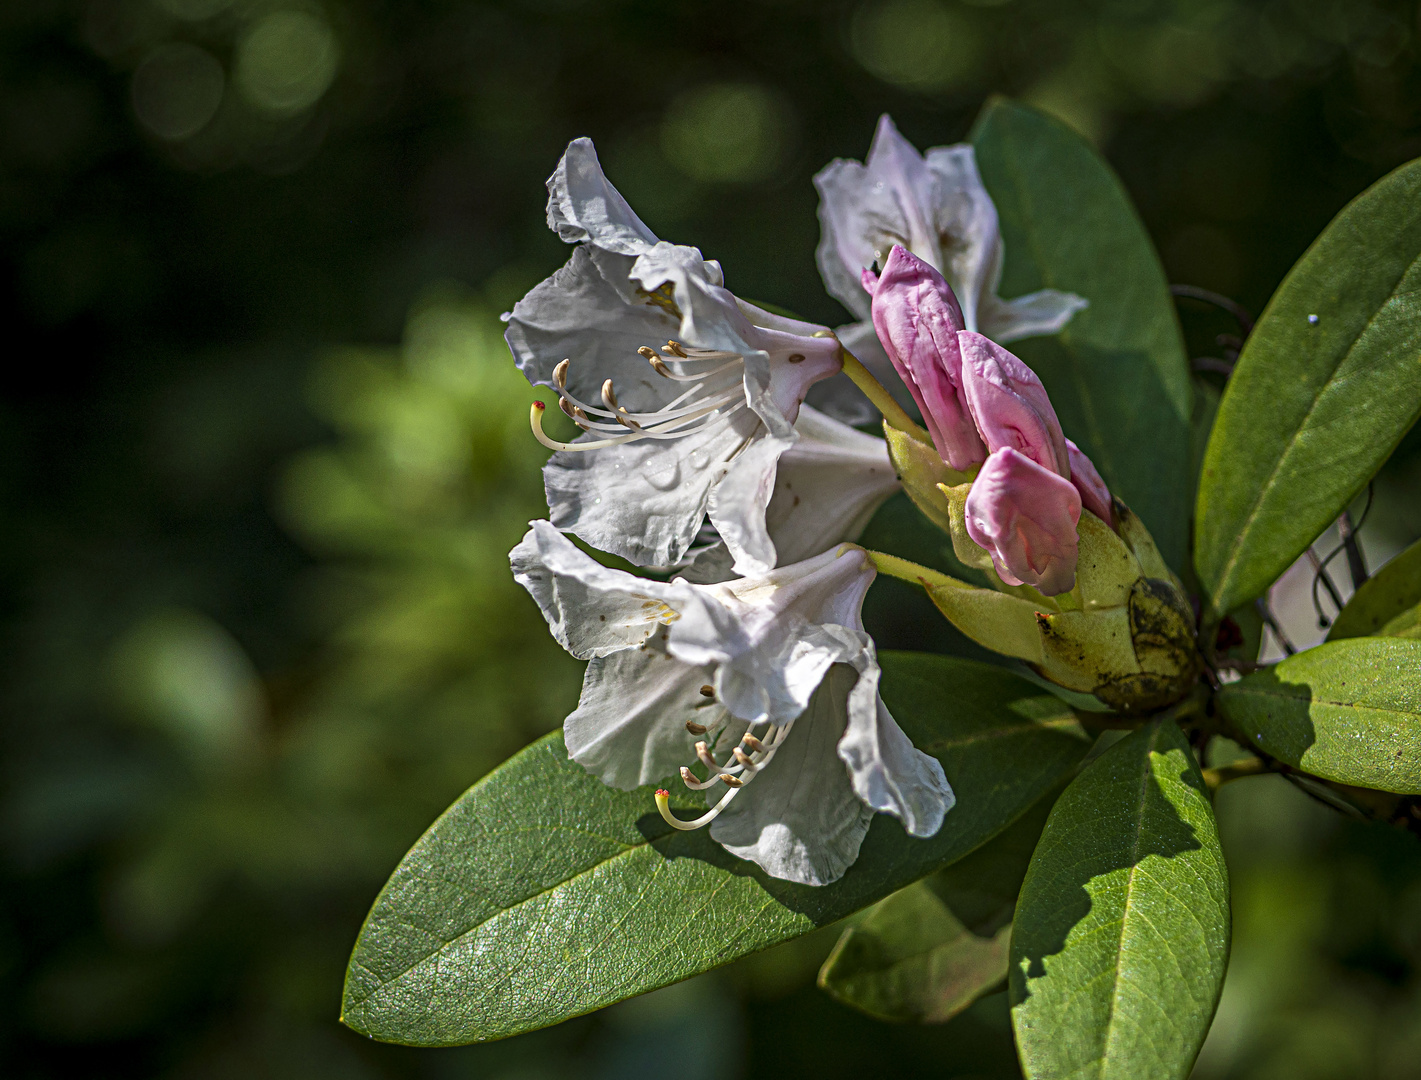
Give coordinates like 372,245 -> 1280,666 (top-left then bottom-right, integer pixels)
512,522 -> 953,885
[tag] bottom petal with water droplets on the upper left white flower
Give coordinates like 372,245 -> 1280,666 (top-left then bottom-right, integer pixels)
543,411 -> 760,566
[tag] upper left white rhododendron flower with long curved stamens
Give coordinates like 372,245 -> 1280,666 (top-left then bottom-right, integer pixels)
506,139 -> 843,573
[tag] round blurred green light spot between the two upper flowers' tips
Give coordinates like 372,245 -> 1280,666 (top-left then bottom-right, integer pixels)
661,82 -> 794,183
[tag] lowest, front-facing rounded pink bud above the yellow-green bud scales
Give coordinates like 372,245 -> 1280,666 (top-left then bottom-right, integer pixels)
965,446 -> 1080,597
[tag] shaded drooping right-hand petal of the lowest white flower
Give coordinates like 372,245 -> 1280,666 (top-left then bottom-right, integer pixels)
838,642 -> 956,837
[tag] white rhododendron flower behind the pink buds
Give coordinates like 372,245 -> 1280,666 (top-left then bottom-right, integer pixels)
811,115 -> 1087,423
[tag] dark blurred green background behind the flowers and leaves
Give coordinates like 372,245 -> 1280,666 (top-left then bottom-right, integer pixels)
8,0 -> 1421,1080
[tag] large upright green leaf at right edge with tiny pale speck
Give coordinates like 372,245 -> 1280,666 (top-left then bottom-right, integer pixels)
1195,161 -> 1421,611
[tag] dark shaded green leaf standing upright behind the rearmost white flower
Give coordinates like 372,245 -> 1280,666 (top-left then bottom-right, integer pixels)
972,98 -> 1194,570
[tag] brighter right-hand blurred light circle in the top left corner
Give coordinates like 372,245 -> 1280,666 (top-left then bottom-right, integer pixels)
234,11 -> 340,114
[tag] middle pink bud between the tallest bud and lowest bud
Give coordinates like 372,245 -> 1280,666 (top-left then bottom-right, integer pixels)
958,330 -> 1070,477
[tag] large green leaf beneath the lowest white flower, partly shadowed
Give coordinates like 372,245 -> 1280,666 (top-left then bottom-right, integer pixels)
342,654 -> 1088,1046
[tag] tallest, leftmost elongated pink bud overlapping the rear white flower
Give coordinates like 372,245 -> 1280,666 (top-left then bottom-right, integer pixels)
863,244 -> 986,470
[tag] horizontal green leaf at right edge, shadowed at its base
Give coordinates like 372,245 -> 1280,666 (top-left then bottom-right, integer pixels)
1218,638 -> 1421,794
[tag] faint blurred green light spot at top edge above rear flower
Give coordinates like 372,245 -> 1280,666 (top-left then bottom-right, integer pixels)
848,0 -> 982,94
